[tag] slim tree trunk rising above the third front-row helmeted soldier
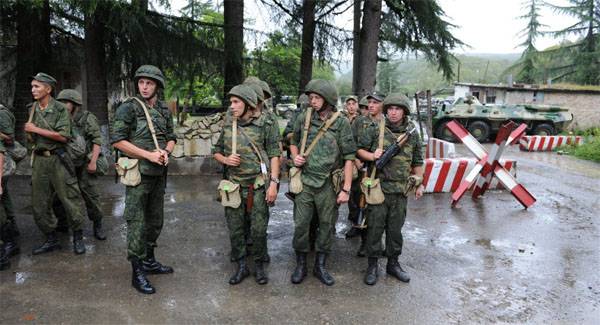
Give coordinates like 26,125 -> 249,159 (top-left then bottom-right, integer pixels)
298,0 -> 316,93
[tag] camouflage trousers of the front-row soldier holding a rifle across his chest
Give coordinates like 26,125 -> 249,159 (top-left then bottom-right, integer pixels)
366,193 -> 406,257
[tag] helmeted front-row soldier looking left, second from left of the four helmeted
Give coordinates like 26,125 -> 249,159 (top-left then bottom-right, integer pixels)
214,84 -> 281,285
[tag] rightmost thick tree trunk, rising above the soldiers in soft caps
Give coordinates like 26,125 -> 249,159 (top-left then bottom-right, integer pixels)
356,0 -> 382,96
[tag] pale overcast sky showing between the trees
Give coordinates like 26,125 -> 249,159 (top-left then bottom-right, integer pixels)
165,0 -> 574,53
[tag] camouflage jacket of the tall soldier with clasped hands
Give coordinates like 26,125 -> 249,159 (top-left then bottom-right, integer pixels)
110,96 -> 177,176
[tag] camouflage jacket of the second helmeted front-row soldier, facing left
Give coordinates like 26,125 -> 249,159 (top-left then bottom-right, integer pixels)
213,113 -> 281,186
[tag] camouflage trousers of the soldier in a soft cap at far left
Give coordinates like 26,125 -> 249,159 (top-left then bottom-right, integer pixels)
31,155 -> 85,234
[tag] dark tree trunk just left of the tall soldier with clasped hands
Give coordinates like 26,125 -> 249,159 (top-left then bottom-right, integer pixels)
84,1 -> 108,125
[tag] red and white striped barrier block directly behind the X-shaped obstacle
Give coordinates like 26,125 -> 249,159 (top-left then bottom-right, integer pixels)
423,158 -> 517,193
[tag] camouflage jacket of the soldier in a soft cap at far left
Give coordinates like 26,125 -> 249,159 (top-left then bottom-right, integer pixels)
27,98 -> 72,150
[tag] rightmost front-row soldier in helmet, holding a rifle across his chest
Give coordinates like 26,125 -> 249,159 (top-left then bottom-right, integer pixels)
358,94 -> 423,285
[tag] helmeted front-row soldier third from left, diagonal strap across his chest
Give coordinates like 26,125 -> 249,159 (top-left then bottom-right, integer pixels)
290,80 -> 356,285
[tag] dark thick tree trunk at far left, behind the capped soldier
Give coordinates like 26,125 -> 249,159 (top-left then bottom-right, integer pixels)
13,0 -> 51,140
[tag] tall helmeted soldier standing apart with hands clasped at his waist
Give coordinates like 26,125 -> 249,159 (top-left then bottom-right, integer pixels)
111,65 -> 176,294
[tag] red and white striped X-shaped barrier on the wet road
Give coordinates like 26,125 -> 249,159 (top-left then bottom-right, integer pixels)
446,120 -> 535,208
